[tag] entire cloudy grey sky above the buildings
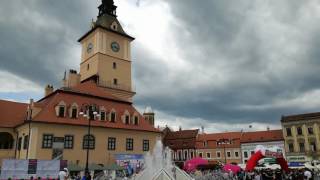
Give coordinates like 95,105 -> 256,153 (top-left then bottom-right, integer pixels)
0,0 -> 320,132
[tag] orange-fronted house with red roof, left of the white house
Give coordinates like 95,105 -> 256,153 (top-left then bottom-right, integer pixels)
197,132 -> 242,163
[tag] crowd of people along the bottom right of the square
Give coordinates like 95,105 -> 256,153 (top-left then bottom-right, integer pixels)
190,168 -> 320,180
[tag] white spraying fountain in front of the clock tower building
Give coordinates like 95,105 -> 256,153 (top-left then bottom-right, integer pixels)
134,140 -> 192,180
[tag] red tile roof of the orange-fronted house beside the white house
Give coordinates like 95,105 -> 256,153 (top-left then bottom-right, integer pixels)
197,132 -> 242,149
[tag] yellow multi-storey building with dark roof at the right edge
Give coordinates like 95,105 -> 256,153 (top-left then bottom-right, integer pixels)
281,112 -> 320,162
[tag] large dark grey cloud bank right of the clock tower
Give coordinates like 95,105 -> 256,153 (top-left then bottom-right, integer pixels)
133,0 -> 320,123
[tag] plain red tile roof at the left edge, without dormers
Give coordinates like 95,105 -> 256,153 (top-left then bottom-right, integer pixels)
0,100 -> 28,128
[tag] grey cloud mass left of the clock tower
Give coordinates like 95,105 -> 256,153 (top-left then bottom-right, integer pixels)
0,0 -> 96,85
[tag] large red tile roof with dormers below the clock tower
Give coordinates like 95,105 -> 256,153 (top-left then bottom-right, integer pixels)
33,83 -> 159,132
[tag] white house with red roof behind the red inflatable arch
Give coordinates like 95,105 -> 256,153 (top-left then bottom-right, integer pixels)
241,130 -> 285,164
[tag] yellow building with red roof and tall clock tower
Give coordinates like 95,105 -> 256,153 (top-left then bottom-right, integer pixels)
0,0 -> 161,169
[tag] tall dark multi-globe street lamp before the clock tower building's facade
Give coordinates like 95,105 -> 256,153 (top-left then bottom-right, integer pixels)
79,104 -> 100,173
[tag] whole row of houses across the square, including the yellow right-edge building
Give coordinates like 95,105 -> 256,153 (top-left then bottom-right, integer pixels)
163,113 -> 320,167
